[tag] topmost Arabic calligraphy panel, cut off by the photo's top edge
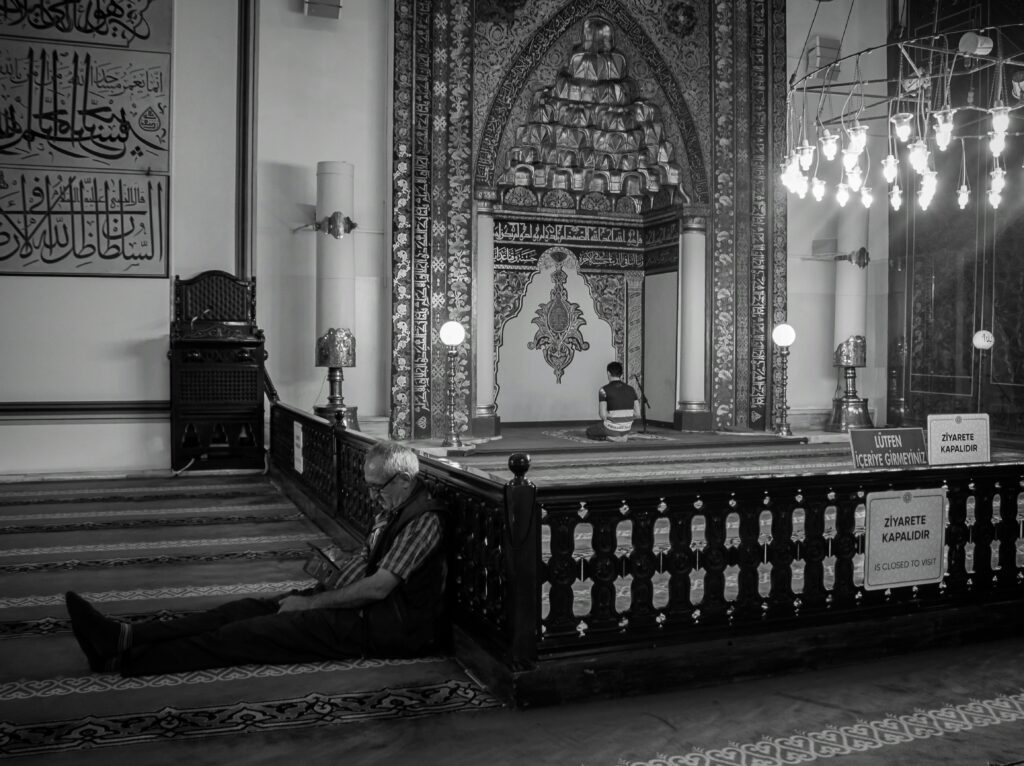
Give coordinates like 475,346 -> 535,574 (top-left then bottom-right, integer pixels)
0,0 -> 171,52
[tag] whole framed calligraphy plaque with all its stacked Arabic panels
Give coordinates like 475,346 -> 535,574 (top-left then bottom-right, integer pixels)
0,0 -> 172,278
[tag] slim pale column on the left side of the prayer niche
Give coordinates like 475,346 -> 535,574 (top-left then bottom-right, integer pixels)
470,200 -> 501,436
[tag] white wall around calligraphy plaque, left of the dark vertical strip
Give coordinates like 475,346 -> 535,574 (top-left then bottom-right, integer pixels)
0,0 -> 238,474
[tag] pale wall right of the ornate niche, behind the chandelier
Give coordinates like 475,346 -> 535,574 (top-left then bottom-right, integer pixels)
775,0 -> 889,425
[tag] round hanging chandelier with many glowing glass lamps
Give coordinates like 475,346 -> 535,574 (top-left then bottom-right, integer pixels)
780,23 -> 1024,210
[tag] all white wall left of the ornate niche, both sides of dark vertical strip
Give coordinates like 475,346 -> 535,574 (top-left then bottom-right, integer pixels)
0,0 -> 391,475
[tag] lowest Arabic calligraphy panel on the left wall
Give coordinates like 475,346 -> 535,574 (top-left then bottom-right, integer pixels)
0,168 -> 169,276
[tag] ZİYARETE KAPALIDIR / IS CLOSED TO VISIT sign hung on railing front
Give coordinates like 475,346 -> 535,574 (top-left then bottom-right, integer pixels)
864,487 -> 946,591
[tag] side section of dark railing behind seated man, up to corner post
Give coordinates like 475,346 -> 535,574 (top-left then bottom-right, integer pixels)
270,405 -> 540,667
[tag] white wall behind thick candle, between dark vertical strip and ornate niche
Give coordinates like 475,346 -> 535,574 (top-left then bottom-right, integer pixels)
256,0 -> 391,418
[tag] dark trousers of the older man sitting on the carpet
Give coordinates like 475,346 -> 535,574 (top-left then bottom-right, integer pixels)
121,598 -> 364,676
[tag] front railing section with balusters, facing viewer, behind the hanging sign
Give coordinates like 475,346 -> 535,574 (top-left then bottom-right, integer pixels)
537,465 -> 1024,654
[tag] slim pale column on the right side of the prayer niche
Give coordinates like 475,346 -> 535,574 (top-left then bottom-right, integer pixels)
675,216 -> 712,431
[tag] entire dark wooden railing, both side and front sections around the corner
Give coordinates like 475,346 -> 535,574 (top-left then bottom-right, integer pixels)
271,405 -> 1024,704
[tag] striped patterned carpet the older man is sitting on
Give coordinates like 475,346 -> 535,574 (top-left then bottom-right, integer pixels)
0,475 -> 499,764
